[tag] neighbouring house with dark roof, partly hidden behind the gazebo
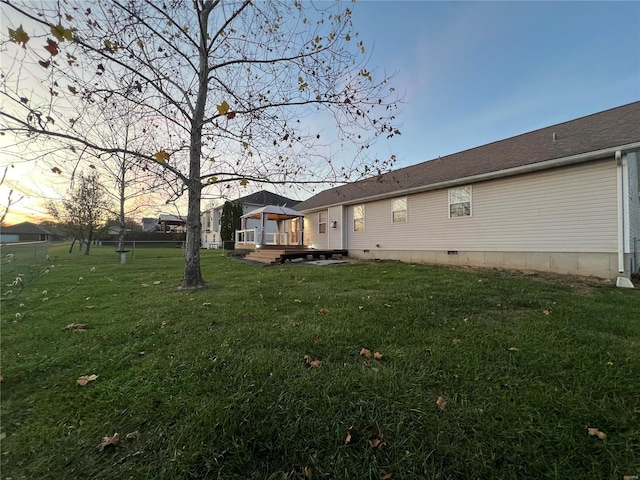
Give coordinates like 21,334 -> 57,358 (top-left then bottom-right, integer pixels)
200,190 -> 299,248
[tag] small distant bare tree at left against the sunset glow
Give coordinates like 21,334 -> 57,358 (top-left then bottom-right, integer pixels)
48,173 -> 111,255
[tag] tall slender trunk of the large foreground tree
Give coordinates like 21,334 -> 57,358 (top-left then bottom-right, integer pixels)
182,0 -> 213,288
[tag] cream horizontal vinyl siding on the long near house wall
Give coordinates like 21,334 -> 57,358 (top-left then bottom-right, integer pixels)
348,160 -> 617,252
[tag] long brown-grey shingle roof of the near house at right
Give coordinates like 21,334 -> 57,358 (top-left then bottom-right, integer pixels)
296,102 -> 640,211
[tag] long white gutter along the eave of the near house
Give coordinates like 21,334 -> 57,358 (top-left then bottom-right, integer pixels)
301,142 -> 640,212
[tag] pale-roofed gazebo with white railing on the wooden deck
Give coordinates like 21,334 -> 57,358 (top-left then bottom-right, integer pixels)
236,205 -> 304,246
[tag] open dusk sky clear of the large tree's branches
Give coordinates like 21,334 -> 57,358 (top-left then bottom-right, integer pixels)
0,0 -> 640,223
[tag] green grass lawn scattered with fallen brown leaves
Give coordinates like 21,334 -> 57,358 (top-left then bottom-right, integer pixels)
0,246 -> 640,480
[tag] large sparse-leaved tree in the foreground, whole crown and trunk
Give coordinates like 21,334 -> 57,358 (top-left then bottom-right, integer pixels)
0,0 -> 399,287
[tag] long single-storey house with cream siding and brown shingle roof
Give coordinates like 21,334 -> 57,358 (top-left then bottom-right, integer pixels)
296,102 -> 640,278
